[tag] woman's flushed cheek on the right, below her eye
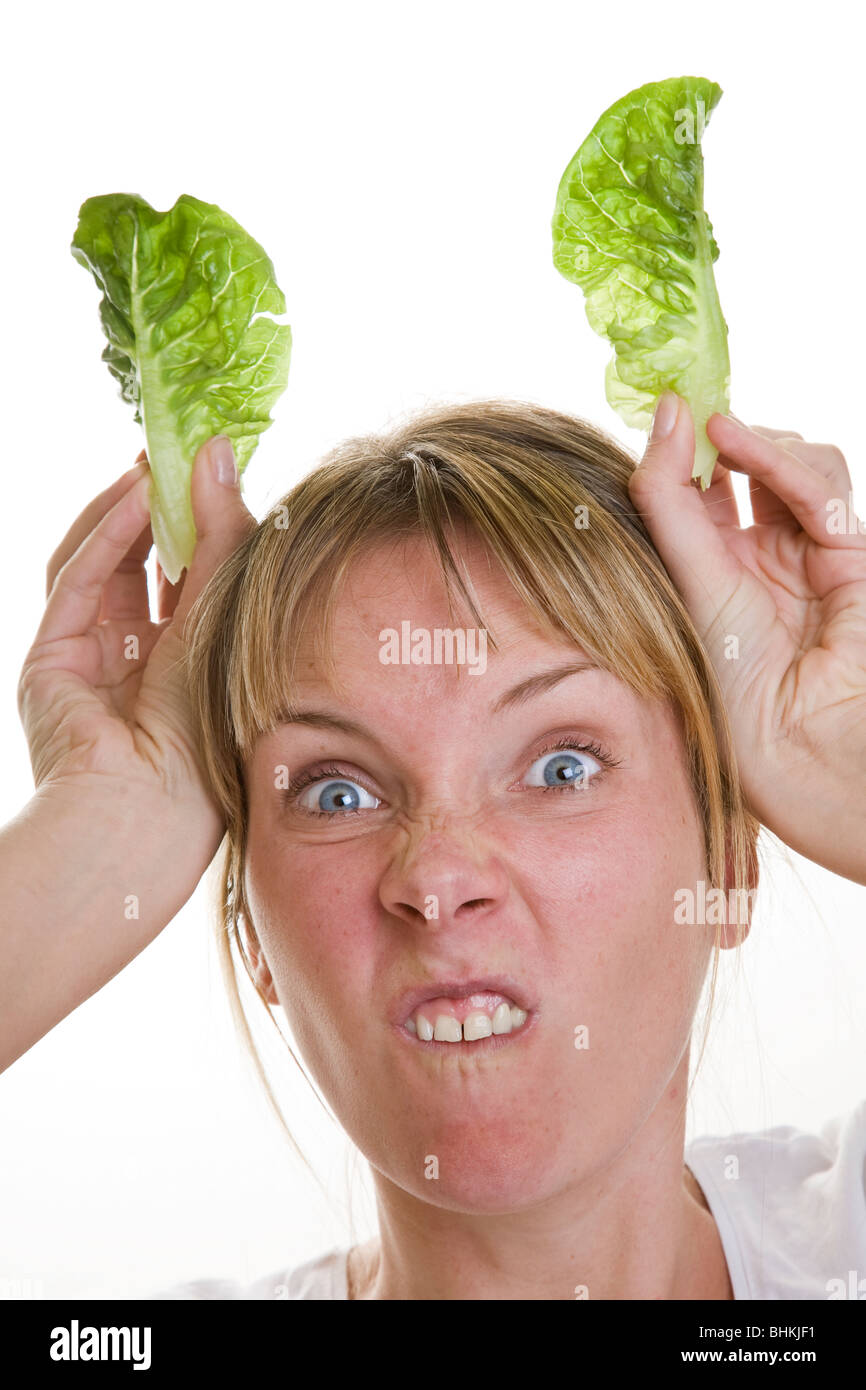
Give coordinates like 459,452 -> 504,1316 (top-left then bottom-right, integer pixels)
496,784 -> 712,1045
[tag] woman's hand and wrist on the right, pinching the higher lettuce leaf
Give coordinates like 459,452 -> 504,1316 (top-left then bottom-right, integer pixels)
628,393 -> 866,884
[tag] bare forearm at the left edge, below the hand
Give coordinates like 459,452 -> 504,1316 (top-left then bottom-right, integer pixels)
0,778 -> 222,1070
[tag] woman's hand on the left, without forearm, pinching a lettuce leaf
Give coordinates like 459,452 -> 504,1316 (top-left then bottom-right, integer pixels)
18,436 -> 256,856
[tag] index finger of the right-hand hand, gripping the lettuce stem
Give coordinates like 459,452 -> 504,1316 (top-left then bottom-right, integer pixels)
706,414 -> 866,546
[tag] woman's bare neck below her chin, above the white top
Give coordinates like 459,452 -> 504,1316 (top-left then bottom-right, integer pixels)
349,1087 -> 733,1301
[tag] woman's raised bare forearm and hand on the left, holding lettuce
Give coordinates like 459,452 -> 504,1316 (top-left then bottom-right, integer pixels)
0,438 -> 256,1070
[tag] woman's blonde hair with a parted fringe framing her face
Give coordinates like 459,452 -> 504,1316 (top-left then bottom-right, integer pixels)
180,400 -> 759,1166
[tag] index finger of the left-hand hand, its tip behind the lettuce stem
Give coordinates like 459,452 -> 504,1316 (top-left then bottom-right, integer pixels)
33,473 -> 150,645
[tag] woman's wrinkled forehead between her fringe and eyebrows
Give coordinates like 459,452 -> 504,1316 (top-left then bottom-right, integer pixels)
278,532 -> 667,737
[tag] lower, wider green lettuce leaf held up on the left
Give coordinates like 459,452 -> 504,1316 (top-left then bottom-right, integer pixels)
71,193 -> 292,584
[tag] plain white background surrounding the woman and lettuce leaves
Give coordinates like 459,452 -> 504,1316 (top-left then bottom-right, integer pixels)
0,0 -> 866,1297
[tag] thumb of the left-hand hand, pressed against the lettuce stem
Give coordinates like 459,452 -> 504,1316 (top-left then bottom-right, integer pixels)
175,435 -> 257,624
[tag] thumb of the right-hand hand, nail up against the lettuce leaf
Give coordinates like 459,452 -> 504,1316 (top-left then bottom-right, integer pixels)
628,391 -> 742,634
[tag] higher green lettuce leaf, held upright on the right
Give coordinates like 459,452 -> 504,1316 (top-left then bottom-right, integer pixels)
552,78 -> 730,488
